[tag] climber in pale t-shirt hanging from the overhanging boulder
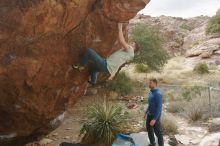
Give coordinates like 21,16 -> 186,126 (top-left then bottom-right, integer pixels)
72,23 -> 137,85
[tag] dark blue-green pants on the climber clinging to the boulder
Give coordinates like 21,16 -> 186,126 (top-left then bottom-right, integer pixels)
80,49 -> 109,84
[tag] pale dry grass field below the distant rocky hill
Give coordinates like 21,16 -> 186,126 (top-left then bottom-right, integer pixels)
144,57 -> 220,85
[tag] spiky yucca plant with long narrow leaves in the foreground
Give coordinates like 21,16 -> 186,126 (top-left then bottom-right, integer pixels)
80,102 -> 127,146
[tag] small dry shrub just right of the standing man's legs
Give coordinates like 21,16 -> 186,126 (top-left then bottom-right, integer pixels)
161,115 -> 178,135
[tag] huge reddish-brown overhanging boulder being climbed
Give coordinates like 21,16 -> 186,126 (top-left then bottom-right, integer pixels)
0,0 -> 149,146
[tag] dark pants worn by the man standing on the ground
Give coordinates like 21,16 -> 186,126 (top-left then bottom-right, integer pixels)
146,115 -> 164,146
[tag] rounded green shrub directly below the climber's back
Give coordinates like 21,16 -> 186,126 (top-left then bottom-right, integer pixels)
108,72 -> 133,96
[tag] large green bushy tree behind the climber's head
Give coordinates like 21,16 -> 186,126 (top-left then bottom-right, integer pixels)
130,23 -> 169,71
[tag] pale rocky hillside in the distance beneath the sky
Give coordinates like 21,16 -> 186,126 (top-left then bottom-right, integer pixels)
130,14 -> 220,66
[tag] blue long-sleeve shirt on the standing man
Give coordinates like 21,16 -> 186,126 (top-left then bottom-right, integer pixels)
146,89 -> 162,120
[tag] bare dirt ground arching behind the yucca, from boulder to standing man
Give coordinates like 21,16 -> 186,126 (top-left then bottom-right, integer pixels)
26,83 -> 151,146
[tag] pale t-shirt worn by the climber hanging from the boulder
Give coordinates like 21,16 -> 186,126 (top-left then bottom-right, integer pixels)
107,48 -> 134,76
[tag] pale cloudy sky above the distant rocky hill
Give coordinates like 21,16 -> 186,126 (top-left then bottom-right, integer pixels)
140,0 -> 220,18
